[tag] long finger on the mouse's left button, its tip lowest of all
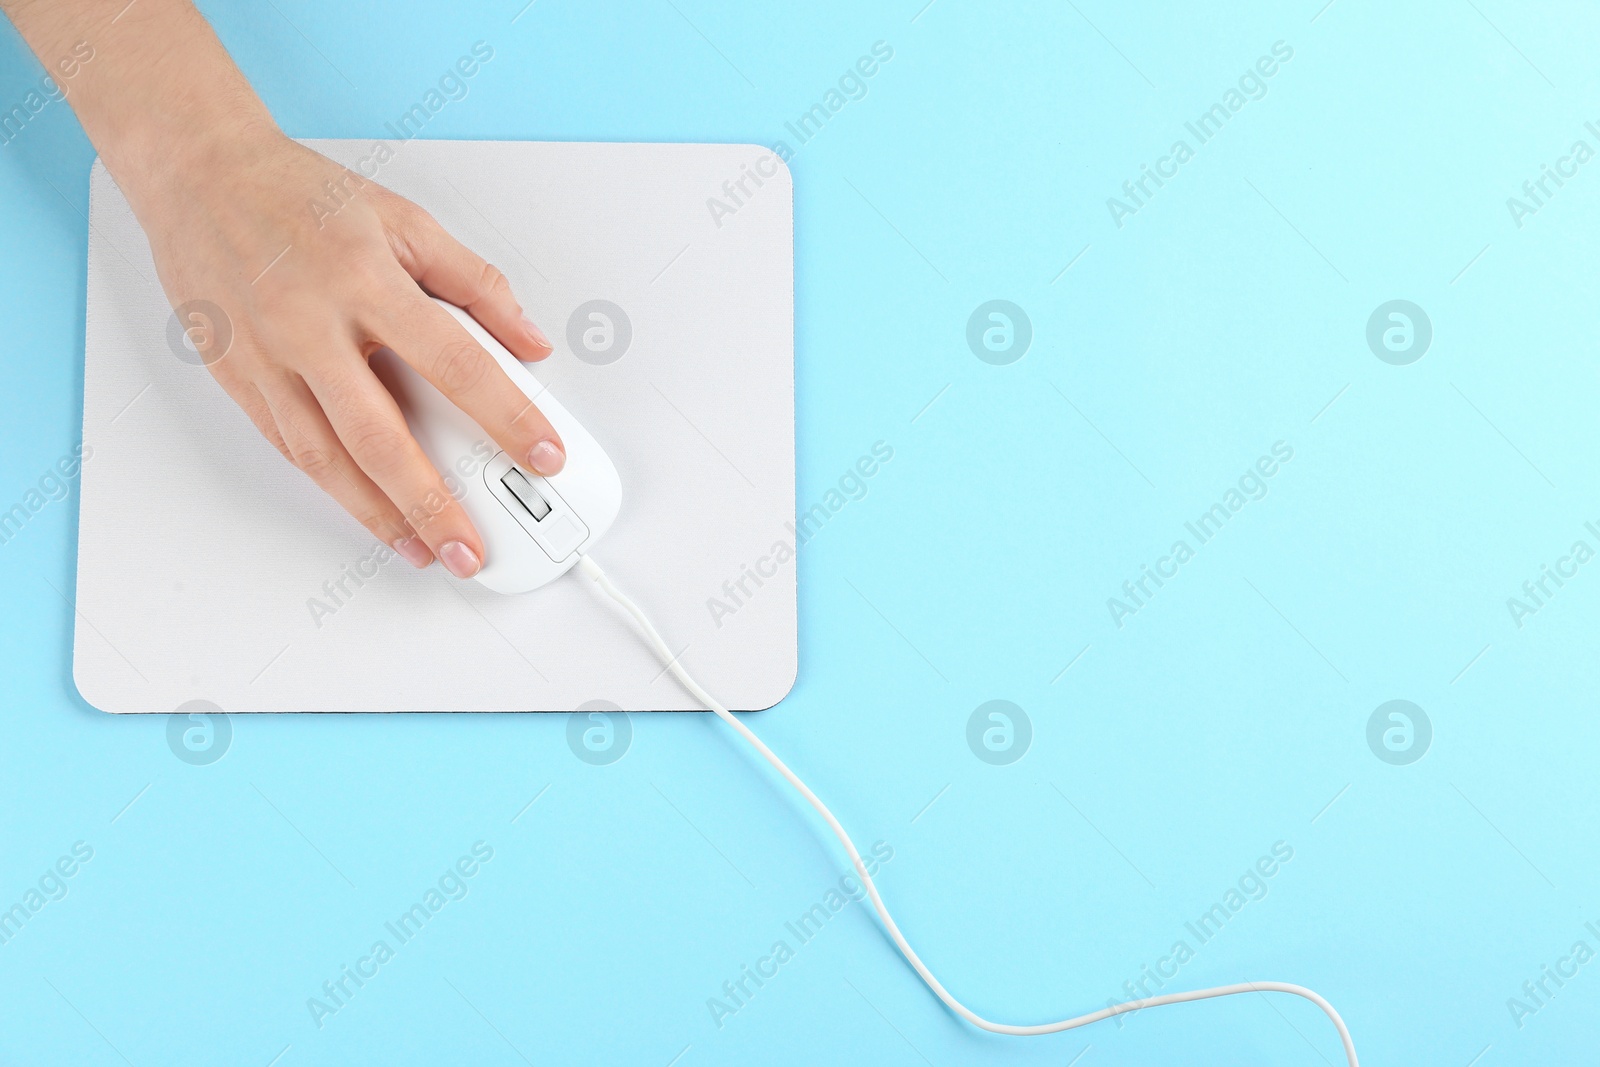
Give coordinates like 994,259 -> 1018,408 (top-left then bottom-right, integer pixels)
306,363 -> 498,577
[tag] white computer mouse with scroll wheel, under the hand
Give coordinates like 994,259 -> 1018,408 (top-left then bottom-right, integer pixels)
371,301 -> 622,593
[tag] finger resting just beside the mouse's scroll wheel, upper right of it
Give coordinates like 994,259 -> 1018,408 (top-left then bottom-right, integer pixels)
376,293 -> 566,475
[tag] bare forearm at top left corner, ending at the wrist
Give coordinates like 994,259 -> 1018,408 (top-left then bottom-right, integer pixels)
0,0 -> 277,214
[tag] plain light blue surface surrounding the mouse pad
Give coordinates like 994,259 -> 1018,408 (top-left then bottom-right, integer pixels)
0,0 -> 1600,1067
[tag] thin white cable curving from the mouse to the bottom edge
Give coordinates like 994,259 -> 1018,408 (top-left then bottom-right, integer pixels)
578,555 -> 1360,1067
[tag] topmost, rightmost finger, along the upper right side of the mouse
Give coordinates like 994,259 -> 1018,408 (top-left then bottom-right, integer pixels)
382,205 -> 552,363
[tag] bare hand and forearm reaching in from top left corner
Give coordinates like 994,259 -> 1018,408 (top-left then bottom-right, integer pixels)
0,0 -> 565,577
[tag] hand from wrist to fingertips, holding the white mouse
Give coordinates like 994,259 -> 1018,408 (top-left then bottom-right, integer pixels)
138,130 -> 565,577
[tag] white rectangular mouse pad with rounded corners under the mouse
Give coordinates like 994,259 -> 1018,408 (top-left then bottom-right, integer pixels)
74,141 -> 803,712
